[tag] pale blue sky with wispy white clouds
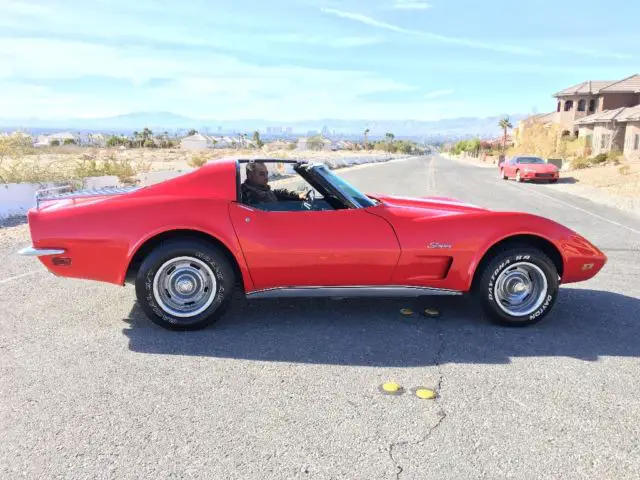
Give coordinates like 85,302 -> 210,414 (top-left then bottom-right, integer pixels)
0,0 -> 640,120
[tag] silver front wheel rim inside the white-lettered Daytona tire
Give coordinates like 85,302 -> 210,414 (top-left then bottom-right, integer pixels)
493,262 -> 549,317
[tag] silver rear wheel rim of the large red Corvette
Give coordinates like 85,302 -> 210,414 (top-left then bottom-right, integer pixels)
153,256 -> 218,318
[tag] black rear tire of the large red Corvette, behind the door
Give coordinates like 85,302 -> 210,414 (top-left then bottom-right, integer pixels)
135,239 -> 235,330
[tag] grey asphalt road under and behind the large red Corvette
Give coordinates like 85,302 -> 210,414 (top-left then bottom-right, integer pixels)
0,158 -> 640,480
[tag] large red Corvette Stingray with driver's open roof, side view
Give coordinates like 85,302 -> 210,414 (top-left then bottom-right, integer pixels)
20,160 -> 606,329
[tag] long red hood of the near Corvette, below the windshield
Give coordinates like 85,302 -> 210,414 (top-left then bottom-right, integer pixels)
372,195 -> 489,217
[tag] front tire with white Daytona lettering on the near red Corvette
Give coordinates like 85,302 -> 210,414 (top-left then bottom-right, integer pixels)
474,245 -> 559,327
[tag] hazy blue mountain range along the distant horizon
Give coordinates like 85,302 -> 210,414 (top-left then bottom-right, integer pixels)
0,112 -> 525,138
